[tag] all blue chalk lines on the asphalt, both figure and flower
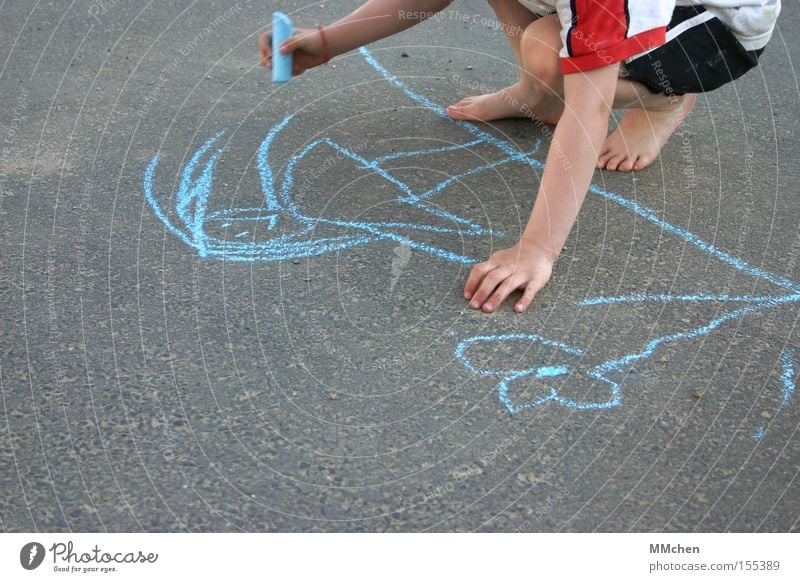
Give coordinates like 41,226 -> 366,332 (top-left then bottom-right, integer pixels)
144,48 -> 800,418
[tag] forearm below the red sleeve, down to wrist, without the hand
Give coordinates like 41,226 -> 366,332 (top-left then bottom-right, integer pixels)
522,67 -> 618,261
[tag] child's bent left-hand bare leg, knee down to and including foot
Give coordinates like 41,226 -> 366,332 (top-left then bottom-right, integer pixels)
447,7 -> 563,123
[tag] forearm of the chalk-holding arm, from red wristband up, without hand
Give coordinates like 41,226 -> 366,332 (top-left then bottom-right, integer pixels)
325,0 -> 452,56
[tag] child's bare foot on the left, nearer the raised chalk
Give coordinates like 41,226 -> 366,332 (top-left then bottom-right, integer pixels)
447,82 -> 561,123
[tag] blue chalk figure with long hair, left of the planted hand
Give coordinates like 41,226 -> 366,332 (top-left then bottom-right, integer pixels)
144,60 -> 539,265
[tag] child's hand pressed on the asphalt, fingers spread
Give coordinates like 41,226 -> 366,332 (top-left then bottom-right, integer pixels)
464,240 -> 556,313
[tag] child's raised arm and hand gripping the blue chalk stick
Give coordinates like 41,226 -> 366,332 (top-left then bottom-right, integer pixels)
258,0 -> 452,75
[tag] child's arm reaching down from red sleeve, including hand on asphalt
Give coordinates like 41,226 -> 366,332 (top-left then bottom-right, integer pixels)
464,64 -> 619,312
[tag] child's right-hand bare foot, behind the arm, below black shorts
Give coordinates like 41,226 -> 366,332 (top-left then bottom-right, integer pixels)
597,94 -> 697,172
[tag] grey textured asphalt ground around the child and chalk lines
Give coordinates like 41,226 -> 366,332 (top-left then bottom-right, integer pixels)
0,0 -> 800,532
